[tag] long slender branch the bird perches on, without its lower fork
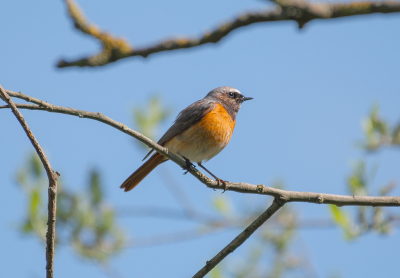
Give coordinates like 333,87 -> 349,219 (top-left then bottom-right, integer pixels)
0,90 -> 400,207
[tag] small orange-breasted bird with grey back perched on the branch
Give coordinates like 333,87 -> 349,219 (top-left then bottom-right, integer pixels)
120,86 -> 253,192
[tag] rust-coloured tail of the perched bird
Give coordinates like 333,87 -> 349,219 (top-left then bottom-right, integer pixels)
120,153 -> 167,192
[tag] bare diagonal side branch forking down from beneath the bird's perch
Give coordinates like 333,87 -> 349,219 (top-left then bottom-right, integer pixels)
193,198 -> 286,278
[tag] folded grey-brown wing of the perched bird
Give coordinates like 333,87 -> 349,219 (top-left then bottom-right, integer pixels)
143,99 -> 215,160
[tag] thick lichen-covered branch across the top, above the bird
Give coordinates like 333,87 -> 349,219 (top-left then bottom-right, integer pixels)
57,0 -> 400,68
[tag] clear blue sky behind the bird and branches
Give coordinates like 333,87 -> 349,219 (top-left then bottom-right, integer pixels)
0,0 -> 400,277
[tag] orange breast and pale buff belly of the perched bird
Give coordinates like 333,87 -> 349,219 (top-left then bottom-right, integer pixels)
165,104 -> 235,162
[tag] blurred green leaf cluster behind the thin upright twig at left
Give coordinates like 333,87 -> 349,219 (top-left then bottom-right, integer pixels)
17,154 -> 126,262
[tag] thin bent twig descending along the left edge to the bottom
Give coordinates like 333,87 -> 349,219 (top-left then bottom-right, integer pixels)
0,85 -> 60,278
